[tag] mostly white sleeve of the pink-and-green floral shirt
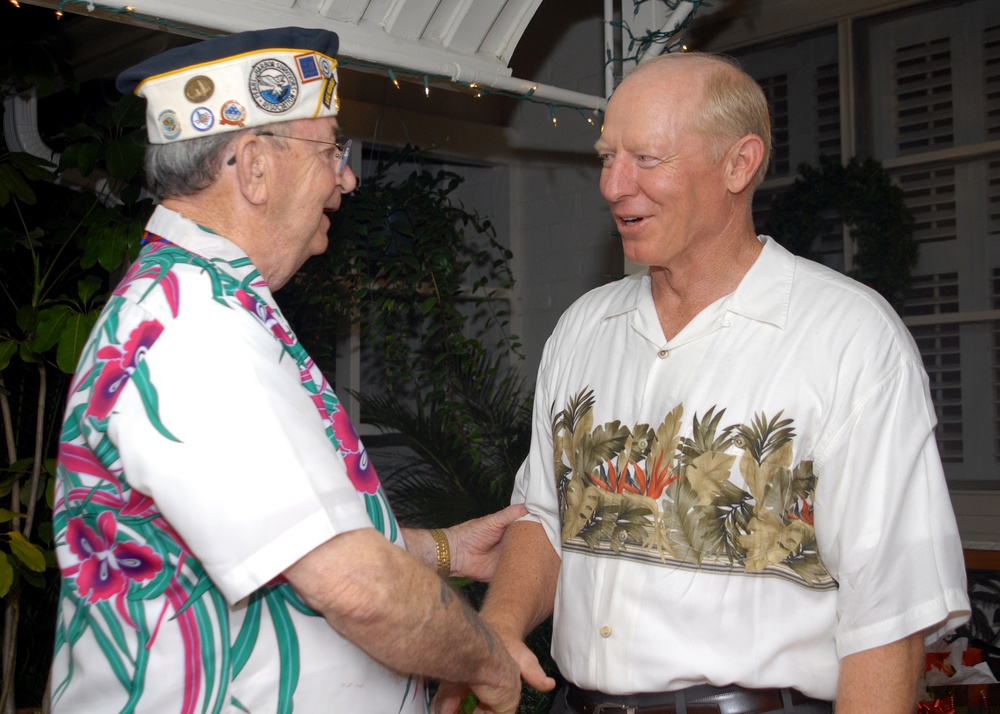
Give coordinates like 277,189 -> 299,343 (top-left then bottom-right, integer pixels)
108,303 -> 372,603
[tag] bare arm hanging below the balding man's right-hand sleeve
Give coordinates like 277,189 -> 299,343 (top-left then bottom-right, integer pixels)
837,632 -> 924,714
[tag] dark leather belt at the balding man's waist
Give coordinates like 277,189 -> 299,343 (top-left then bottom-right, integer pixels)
566,685 -> 821,714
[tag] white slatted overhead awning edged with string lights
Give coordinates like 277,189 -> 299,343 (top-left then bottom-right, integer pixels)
22,0 -> 605,109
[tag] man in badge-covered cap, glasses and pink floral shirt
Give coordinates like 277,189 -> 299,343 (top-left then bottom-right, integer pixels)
52,28 -> 524,714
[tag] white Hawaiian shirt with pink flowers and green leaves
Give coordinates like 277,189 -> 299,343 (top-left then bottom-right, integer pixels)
52,207 -> 427,714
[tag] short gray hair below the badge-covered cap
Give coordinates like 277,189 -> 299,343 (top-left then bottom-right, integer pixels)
146,122 -> 298,199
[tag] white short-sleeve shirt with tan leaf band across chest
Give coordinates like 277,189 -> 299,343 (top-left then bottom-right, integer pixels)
514,238 -> 969,700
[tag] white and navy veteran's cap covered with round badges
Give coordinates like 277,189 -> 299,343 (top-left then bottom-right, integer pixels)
116,27 -> 339,144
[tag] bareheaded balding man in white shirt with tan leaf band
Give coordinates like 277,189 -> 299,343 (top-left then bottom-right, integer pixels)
450,54 -> 969,714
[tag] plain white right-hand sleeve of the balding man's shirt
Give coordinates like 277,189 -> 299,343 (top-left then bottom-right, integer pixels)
816,355 -> 969,658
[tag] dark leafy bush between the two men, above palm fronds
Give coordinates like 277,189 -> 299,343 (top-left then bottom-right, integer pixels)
282,146 -> 520,399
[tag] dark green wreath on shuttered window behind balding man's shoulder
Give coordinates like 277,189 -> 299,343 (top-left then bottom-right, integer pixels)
765,157 -> 918,312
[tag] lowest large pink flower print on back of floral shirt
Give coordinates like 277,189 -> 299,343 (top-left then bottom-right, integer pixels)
66,511 -> 163,604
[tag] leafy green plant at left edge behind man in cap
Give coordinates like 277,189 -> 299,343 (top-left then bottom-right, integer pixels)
0,65 -> 152,711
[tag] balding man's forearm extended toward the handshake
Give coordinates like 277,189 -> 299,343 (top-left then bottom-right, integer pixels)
481,521 -> 562,639
